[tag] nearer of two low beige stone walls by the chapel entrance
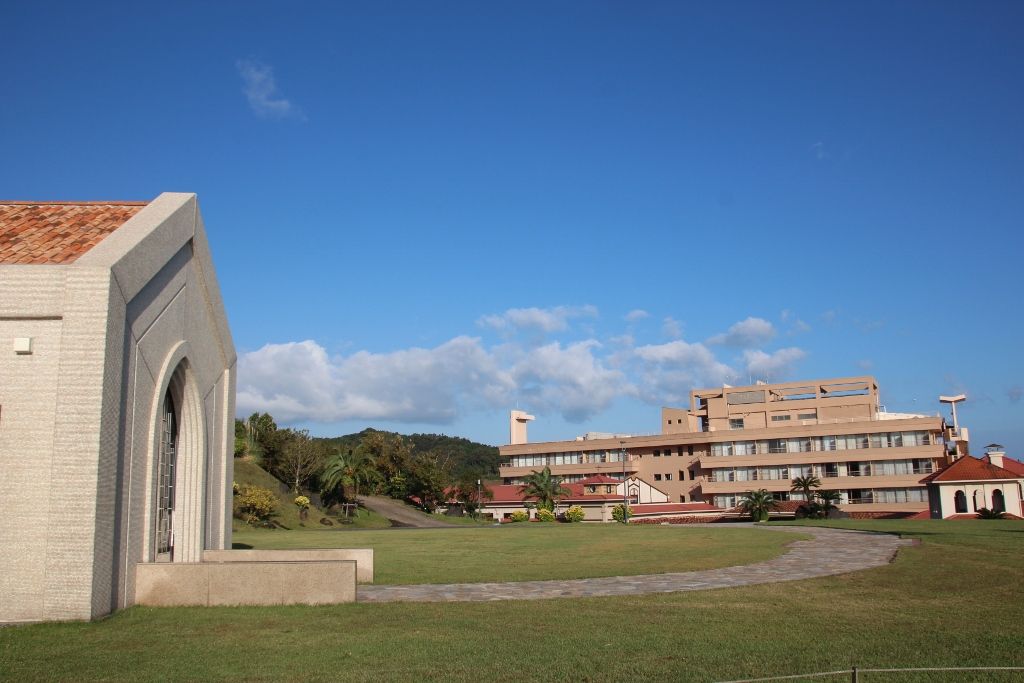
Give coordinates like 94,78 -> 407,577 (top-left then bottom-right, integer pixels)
133,561 -> 356,607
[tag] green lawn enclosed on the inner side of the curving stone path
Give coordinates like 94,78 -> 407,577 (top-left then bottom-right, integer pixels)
233,524 -> 794,584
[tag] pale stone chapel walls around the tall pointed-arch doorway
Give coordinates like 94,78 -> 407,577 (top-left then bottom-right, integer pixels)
0,194 -> 236,622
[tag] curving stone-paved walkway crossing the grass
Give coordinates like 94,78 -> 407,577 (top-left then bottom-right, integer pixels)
356,524 -> 913,602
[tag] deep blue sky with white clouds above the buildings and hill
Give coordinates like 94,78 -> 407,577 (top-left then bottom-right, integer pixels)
6,2 -> 1024,457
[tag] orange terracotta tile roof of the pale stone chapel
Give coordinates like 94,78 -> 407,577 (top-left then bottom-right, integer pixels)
0,201 -> 148,264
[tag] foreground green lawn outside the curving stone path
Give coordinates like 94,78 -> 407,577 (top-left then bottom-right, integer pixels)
0,521 -> 1024,683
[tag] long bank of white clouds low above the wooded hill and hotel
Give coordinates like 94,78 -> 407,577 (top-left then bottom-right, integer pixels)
238,306 -> 806,424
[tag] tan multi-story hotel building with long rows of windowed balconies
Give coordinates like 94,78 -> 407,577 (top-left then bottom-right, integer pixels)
500,377 -> 954,512
